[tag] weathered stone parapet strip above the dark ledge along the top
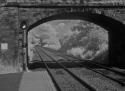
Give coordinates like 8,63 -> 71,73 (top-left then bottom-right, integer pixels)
1,0 -> 125,5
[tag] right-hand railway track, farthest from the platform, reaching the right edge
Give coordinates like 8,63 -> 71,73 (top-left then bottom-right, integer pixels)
41,48 -> 125,86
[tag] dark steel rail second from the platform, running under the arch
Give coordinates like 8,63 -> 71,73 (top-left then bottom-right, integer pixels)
38,49 -> 96,91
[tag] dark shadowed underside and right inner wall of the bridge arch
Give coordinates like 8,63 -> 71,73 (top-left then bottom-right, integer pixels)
27,12 -> 125,68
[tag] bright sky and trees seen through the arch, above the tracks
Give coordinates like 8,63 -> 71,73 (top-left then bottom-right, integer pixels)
28,19 -> 108,64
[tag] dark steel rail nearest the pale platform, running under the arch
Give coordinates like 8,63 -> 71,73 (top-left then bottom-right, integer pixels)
35,48 -> 62,91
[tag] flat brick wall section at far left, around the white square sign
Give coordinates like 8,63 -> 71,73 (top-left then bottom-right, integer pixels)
0,8 -> 18,64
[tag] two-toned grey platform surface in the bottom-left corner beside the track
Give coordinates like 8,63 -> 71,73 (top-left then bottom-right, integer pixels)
0,71 -> 56,91
